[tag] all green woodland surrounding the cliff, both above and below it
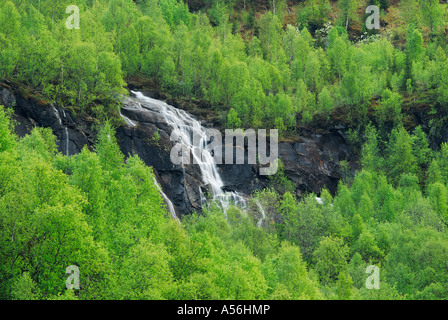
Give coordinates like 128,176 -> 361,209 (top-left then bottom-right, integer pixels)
0,0 -> 448,299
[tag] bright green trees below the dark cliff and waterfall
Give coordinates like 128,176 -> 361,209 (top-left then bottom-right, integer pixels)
0,104 -> 448,299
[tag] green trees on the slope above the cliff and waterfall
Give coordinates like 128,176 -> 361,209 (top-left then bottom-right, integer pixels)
0,0 -> 448,134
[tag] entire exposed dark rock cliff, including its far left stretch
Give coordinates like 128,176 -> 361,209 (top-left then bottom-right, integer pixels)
0,84 -> 355,214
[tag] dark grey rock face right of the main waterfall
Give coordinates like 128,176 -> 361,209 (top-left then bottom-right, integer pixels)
215,132 -> 355,197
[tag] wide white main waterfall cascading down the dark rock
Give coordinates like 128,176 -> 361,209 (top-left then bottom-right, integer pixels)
128,91 -> 246,213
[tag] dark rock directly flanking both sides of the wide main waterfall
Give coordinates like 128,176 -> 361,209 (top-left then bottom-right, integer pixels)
117,91 -> 355,212
